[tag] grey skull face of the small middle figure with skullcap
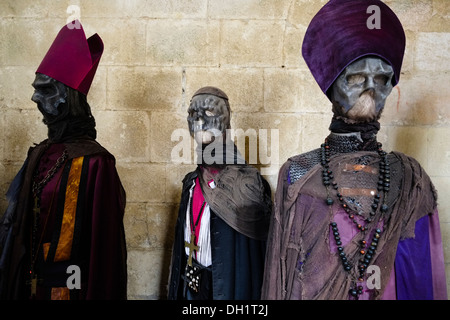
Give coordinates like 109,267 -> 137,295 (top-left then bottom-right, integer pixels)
187,94 -> 230,144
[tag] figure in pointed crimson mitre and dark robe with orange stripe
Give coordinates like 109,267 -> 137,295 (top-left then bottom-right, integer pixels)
0,20 -> 127,300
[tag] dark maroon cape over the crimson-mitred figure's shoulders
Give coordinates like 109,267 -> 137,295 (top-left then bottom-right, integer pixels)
0,139 -> 127,299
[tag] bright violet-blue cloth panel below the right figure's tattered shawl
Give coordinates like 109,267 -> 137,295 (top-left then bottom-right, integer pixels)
395,216 -> 433,300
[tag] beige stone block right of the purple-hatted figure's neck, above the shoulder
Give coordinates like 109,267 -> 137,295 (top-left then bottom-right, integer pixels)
383,127 -> 428,170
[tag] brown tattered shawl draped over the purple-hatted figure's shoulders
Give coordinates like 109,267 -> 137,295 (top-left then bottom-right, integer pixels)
262,152 -> 436,300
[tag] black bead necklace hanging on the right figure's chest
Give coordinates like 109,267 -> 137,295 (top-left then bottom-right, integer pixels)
321,140 -> 390,299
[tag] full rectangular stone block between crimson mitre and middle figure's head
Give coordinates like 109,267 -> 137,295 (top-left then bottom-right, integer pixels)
107,67 -> 182,111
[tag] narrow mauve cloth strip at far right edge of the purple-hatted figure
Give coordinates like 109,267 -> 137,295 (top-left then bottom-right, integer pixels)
429,210 -> 448,300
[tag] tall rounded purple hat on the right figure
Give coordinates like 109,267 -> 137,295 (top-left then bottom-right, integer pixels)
302,0 -> 405,94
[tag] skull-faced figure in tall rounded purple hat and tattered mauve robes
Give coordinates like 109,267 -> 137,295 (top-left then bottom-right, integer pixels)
262,0 -> 447,300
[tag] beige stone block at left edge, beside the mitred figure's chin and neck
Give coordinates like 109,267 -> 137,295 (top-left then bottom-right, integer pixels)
3,109 -> 47,161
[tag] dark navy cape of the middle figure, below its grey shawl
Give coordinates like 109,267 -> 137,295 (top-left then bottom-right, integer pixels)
168,165 -> 270,300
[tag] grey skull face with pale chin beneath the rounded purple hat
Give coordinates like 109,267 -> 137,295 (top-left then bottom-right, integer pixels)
330,57 -> 394,122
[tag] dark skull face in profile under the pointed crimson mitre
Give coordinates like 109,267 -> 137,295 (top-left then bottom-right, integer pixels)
31,73 -> 67,117
